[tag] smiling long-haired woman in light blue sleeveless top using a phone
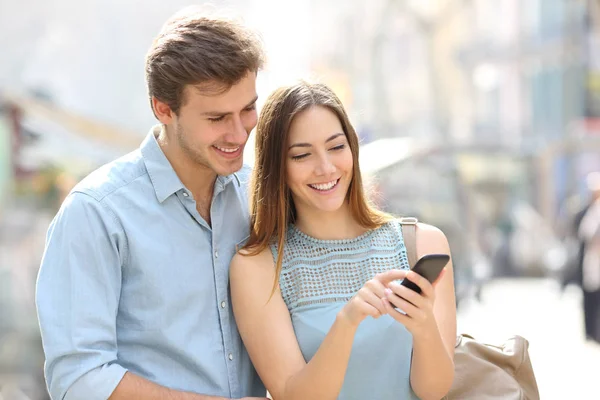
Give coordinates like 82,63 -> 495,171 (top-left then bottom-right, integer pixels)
230,82 -> 456,400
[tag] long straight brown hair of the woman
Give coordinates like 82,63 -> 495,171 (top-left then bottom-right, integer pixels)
242,81 -> 392,293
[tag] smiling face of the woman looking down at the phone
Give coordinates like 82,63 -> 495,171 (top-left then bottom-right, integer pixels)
286,106 -> 354,213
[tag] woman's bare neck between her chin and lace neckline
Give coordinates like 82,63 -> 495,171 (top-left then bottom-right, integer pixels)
295,205 -> 367,240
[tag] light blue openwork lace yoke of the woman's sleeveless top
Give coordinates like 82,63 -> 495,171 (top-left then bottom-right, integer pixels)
271,220 -> 409,311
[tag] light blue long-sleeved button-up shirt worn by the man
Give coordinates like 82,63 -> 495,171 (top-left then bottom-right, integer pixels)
36,127 -> 266,400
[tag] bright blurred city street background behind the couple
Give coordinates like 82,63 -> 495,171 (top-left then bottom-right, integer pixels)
0,0 -> 600,400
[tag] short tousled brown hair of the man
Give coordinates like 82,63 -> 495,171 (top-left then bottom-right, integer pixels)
146,7 -> 264,114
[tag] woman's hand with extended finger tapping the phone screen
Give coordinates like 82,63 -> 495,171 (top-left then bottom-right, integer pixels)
340,269 -> 408,327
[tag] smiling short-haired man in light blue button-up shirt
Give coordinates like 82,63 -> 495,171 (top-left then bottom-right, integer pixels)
36,10 -> 266,400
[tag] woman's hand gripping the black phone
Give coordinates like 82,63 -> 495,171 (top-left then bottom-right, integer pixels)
382,268 -> 446,338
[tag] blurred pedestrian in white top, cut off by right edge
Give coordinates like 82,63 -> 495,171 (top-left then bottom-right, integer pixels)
578,172 -> 600,343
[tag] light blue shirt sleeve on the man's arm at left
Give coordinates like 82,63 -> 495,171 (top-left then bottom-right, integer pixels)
36,192 -> 126,400
